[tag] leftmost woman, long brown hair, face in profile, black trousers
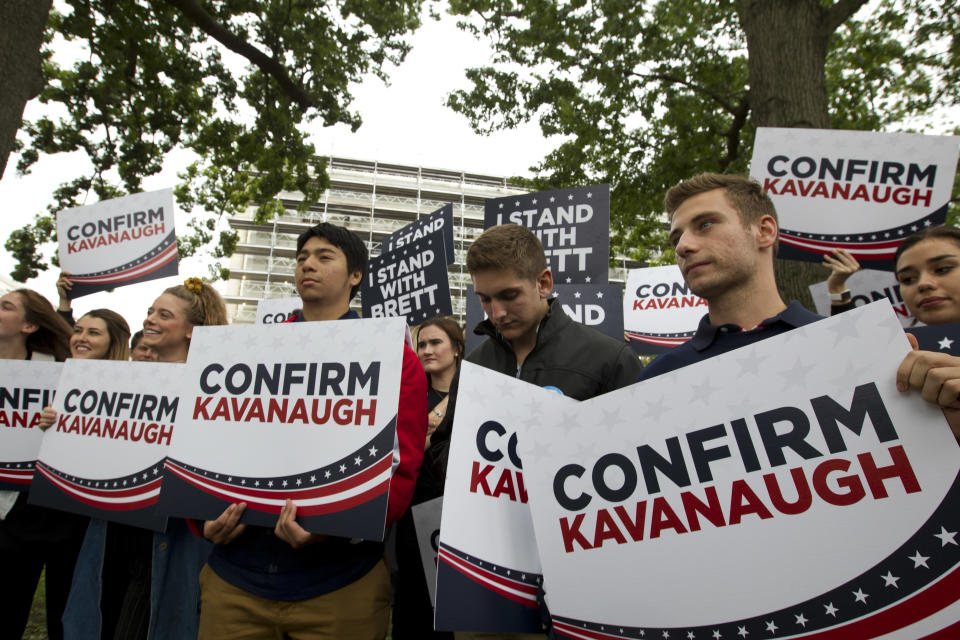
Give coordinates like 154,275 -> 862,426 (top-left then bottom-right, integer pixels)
0,289 -> 87,640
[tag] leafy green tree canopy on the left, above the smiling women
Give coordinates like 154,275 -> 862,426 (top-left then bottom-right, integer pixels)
6,0 -> 421,280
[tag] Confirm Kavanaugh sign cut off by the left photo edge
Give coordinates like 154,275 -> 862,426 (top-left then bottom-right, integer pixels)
0,360 -> 63,491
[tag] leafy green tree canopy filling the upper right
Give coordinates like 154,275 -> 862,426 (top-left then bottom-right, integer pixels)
448,0 -> 960,260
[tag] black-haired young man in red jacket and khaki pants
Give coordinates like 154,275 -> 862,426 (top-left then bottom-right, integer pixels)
199,223 -> 427,640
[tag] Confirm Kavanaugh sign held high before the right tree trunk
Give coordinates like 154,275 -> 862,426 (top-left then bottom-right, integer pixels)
750,127 -> 958,270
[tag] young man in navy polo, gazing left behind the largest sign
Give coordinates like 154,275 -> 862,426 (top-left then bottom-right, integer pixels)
640,173 -> 820,380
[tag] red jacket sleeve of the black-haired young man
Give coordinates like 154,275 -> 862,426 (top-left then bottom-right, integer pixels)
387,344 -> 427,526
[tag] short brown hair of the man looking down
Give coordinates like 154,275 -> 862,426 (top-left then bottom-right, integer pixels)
467,224 -> 547,280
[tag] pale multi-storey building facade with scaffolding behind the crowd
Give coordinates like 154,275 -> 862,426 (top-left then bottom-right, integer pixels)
224,158 -> 625,324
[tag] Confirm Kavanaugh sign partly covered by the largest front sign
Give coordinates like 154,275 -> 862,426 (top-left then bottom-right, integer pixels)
435,362 -> 564,633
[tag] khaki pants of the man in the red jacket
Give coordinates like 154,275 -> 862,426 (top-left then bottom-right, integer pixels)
199,561 -> 390,640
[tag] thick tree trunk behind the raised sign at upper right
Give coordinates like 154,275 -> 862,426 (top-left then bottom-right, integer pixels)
738,0 -> 848,310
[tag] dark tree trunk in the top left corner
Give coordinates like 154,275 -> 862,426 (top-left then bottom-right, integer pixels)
0,0 -> 53,178
